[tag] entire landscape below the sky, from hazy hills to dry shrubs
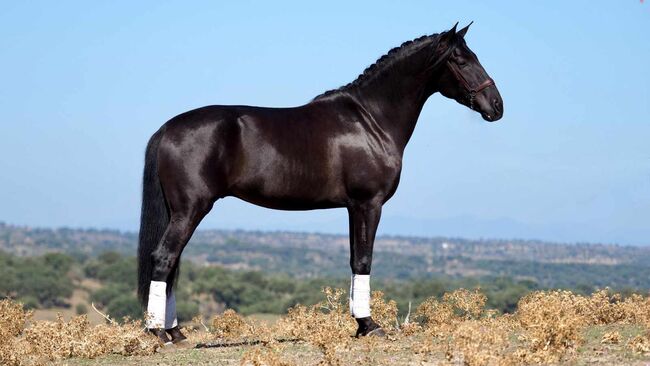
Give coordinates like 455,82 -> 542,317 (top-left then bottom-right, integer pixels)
0,225 -> 650,365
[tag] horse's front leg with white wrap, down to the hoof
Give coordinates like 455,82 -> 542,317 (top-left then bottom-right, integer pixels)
348,201 -> 384,337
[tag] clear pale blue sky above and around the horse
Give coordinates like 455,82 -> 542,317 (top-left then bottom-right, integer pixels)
0,0 -> 650,245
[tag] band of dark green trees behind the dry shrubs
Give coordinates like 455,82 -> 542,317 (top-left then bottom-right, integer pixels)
0,252 -> 638,321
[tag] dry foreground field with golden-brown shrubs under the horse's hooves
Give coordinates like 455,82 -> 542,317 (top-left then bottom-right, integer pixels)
0,288 -> 650,365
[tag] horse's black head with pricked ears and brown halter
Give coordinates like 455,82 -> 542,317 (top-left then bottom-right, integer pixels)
436,23 -> 503,122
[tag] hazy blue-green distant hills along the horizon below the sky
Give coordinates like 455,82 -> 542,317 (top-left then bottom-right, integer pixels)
0,223 -> 650,288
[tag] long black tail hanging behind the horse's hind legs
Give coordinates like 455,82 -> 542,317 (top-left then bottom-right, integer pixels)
138,128 -> 169,306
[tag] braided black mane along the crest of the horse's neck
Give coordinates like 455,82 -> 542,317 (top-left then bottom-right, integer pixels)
313,34 -> 439,100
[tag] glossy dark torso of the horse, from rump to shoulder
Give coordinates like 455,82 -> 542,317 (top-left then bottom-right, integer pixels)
159,102 -> 399,210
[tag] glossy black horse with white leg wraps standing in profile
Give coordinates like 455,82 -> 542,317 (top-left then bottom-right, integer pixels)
138,23 -> 503,344
